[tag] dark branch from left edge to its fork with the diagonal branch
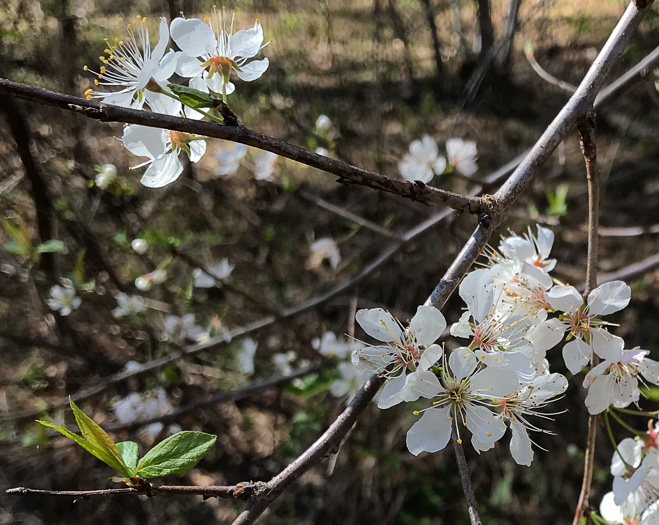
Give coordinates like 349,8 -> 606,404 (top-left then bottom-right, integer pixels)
0,79 -> 486,213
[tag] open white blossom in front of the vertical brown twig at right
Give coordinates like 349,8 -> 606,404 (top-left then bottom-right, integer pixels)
545,281 -> 631,374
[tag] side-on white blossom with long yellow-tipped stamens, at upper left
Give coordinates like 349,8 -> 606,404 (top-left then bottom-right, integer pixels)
85,15 -> 181,115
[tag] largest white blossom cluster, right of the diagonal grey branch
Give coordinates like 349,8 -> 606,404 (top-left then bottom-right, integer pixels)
352,226 -> 648,465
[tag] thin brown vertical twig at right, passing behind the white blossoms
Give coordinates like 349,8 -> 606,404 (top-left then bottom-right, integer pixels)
572,111 -> 600,525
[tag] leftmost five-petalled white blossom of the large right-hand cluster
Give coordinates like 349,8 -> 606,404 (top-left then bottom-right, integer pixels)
352,306 -> 446,408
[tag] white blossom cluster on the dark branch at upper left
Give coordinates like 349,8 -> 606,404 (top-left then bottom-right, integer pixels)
85,8 -> 274,189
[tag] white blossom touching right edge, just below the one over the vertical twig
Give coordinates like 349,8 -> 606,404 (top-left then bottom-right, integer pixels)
583,348 -> 659,414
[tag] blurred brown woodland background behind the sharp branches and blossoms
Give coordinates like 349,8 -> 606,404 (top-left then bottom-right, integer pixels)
0,0 -> 659,524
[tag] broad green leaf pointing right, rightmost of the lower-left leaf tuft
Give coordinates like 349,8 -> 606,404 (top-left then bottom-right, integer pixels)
135,431 -> 217,478
